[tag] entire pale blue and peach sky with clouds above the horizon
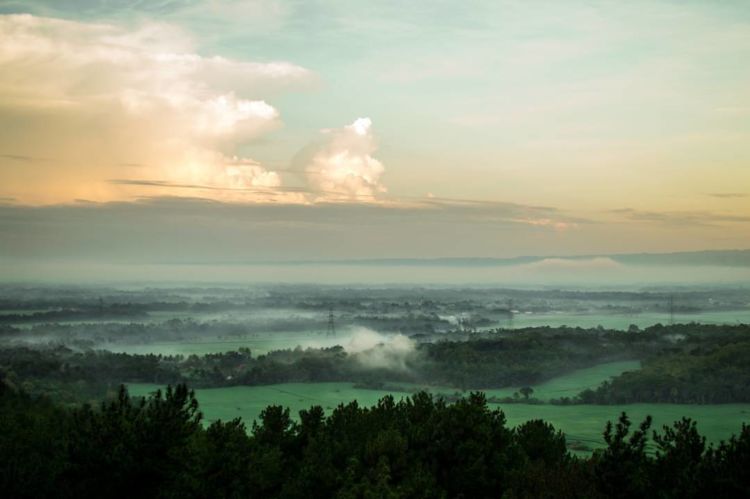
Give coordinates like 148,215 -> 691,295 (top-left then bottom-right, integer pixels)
0,0 -> 750,276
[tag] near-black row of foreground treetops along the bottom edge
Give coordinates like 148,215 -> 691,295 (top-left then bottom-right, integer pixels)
0,383 -> 750,499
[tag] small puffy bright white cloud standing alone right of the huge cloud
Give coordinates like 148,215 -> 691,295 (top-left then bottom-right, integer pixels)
305,118 -> 386,199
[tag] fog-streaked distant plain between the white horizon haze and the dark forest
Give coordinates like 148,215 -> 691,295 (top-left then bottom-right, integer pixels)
0,282 -> 750,356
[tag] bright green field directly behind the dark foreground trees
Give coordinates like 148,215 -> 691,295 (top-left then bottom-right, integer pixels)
129,362 -> 750,454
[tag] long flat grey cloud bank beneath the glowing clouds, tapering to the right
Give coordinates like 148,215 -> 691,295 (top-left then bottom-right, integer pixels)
0,196 -> 590,264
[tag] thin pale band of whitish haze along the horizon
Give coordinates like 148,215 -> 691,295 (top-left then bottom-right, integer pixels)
5,258 -> 750,289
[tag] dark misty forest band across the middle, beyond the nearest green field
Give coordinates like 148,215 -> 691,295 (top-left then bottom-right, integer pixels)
0,324 -> 750,404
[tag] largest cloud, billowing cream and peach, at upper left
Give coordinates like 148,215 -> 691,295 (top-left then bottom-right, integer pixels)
0,14 -> 311,201
